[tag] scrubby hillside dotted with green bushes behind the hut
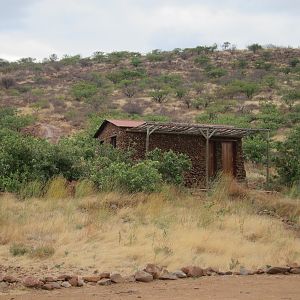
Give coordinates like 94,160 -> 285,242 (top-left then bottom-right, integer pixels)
0,47 -> 300,141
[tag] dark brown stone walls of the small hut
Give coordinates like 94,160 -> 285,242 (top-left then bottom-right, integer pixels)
98,123 -> 246,187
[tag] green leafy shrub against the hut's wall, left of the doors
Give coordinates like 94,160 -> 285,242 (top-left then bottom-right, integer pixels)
147,149 -> 191,184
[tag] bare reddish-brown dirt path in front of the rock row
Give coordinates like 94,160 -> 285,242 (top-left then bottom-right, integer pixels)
0,275 -> 300,300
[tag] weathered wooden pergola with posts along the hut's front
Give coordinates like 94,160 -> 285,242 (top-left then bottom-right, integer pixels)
127,122 -> 270,190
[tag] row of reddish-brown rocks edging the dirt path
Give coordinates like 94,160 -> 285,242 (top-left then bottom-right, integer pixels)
0,263 -> 300,291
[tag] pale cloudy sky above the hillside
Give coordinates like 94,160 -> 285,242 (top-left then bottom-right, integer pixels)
0,0 -> 300,60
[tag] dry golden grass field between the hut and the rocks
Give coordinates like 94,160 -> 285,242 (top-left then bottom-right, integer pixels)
0,179 -> 300,273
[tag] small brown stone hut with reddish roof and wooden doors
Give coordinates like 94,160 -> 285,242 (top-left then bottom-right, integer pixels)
94,120 -> 268,187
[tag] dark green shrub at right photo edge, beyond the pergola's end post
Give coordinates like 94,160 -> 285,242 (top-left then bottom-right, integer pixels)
275,125 -> 300,186
